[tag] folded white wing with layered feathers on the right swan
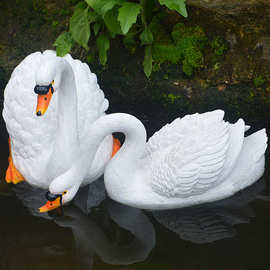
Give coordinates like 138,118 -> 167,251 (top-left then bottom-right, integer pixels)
147,111 -> 235,197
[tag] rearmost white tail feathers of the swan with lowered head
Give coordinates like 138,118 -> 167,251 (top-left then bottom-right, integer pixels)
229,129 -> 268,190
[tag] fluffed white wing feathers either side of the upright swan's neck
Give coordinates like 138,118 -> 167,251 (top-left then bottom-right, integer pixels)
3,51 -> 112,189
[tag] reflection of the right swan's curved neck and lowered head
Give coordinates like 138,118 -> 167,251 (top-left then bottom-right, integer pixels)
55,200 -> 156,269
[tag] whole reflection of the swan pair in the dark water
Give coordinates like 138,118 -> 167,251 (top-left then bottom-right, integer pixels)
11,176 -> 265,269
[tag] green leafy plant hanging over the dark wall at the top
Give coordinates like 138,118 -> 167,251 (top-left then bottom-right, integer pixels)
54,0 -> 189,77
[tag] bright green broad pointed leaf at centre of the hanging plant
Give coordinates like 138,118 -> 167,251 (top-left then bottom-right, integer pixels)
118,2 -> 141,34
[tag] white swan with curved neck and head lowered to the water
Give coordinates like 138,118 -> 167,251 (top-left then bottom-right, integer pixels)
47,109 -> 267,210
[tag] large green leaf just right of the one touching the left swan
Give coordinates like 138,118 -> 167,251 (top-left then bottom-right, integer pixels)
70,8 -> 90,49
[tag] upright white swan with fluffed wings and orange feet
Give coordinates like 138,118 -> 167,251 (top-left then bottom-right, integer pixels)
3,51 -> 120,211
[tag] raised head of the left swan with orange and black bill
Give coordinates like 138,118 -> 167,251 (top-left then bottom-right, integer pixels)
34,56 -> 67,116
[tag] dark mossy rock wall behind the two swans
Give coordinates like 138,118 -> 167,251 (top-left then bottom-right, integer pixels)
0,0 -> 270,135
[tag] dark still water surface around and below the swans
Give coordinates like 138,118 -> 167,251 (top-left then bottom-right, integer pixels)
0,97 -> 270,270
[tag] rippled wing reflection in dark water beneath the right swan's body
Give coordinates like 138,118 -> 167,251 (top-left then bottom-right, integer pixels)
152,179 -> 265,244
